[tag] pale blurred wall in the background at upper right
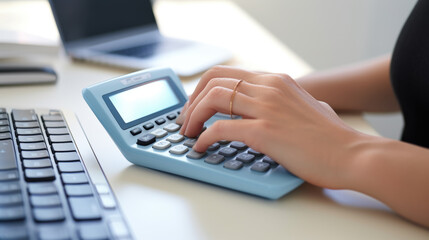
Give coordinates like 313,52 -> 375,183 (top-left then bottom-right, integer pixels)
233,0 -> 416,139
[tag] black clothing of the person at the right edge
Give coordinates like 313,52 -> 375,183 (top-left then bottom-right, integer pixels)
390,0 -> 429,148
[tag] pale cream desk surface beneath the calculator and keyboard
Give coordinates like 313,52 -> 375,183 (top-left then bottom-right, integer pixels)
0,1 -> 429,239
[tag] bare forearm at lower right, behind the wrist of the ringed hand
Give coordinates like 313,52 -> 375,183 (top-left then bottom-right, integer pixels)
344,137 -> 429,227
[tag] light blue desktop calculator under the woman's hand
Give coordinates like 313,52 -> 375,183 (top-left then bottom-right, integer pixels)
83,68 -> 303,199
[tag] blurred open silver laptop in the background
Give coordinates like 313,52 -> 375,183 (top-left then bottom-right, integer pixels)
49,0 -> 231,76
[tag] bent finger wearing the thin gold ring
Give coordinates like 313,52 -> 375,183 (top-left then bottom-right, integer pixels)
180,87 -> 258,137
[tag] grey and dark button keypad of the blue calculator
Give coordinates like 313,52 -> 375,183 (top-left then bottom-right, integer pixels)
130,110 -> 278,173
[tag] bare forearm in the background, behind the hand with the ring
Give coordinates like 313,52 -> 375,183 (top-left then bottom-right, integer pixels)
297,56 -> 399,112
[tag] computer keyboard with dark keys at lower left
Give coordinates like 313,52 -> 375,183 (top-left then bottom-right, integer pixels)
0,108 -> 131,240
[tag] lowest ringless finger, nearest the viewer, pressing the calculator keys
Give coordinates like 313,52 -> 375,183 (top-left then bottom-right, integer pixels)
193,119 -> 256,152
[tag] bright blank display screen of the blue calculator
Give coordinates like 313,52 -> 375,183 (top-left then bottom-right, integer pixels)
109,79 -> 180,124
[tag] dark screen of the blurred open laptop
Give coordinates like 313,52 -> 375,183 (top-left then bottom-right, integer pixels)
49,0 -> 156,42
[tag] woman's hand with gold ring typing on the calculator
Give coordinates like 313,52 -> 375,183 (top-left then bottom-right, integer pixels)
177,66 -> 369,188
